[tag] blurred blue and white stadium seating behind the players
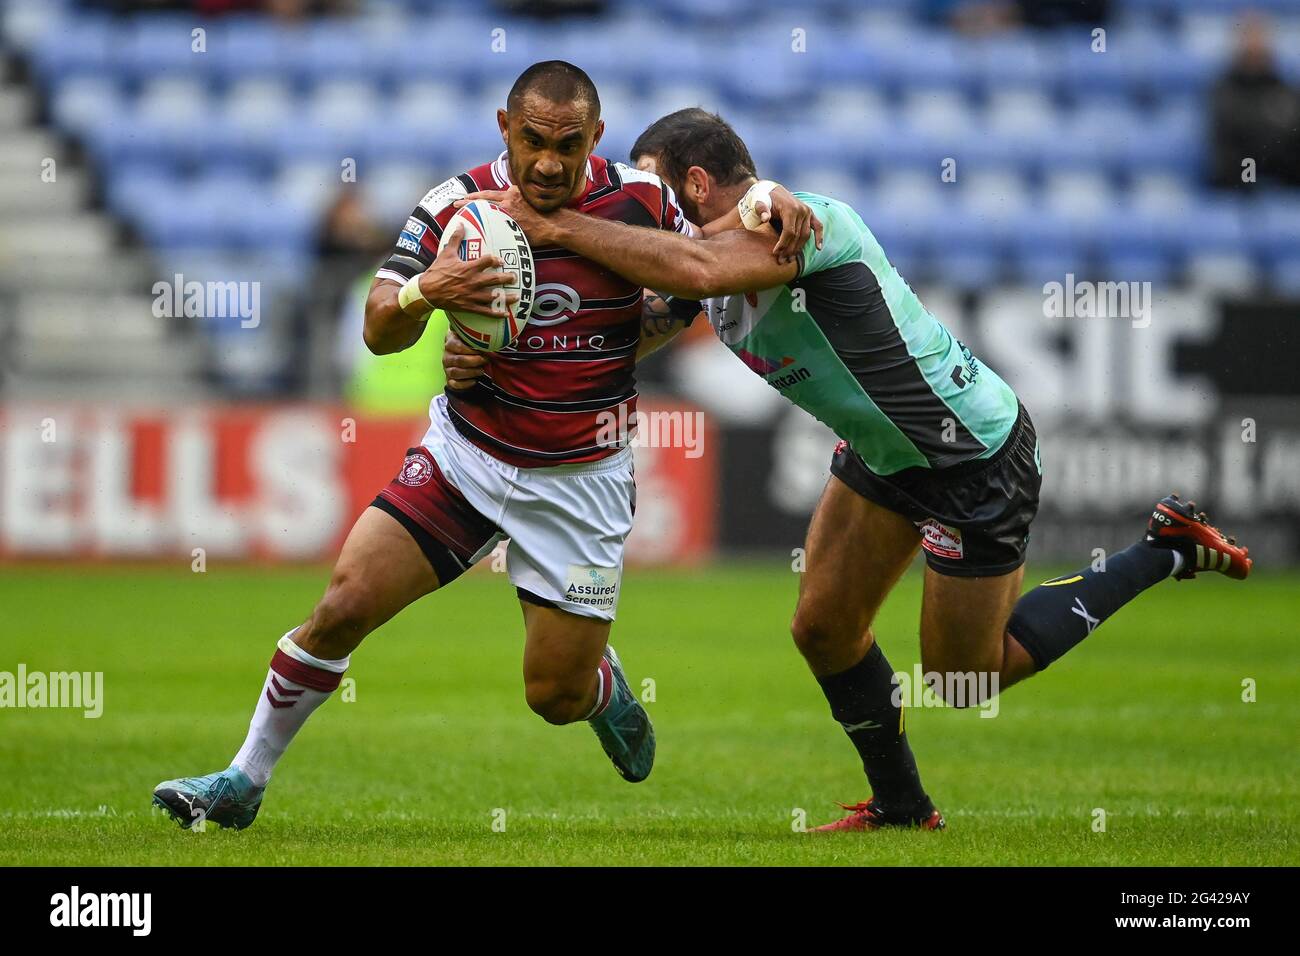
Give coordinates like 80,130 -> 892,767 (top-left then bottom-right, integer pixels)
20,0 -> 1300,300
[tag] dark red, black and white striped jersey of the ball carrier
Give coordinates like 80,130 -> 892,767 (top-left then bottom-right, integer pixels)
377,153 -> 692,468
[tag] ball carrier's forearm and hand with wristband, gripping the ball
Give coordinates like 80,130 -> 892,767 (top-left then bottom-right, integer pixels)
363,225 -> 510,355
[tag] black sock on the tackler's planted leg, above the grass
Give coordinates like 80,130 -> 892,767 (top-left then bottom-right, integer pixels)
818,644 -> 933,816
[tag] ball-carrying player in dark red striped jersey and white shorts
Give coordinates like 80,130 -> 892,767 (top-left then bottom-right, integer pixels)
153,61 -> 816,829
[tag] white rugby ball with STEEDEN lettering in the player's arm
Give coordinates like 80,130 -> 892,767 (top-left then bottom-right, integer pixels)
438,199 -> 536,352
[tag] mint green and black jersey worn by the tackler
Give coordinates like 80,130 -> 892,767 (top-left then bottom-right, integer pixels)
703,193 -> 1019,475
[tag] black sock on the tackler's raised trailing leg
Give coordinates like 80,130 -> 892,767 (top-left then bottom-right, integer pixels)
1006,541 -> 1174,670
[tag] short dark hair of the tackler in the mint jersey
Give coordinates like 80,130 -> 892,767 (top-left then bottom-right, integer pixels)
632,107 -> 755,189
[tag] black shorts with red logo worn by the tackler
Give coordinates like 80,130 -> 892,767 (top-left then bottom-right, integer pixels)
831,405 -> 1043,578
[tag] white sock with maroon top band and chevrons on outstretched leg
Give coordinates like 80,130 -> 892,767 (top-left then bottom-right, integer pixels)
230,628 -> 350,787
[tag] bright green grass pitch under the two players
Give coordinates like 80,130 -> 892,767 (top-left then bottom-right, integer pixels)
0,562 -> 1300,866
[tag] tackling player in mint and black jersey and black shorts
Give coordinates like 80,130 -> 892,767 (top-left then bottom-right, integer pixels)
445,109 -> 1251,830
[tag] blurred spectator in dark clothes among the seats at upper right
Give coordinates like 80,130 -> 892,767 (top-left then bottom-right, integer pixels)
1210,16 -> 1300,189
